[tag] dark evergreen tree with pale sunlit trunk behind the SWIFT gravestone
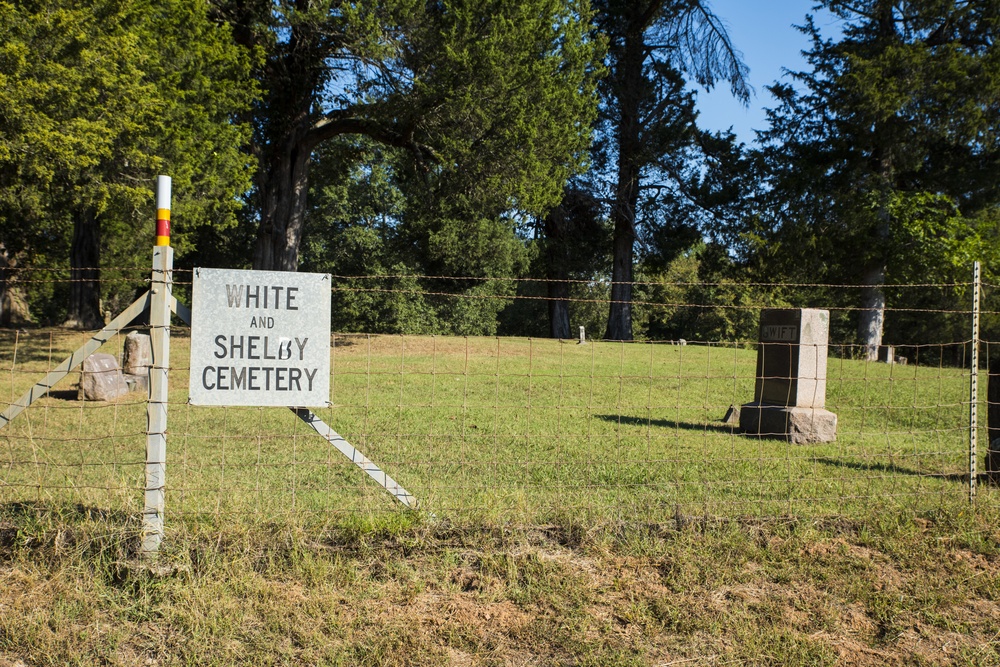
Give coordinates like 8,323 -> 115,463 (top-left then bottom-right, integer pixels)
763,0 -> 1000,359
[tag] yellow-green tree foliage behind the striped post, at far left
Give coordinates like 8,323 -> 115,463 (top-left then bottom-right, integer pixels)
0,0 -> 255,318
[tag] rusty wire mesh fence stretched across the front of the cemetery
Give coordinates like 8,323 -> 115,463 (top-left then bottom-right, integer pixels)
0,271 -> 1000,524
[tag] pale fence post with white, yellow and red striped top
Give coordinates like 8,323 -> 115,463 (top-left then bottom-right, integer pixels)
140,176 -> 174,556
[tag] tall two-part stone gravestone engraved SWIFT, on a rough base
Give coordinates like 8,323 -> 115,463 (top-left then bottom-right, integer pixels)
740,308 -> 837,443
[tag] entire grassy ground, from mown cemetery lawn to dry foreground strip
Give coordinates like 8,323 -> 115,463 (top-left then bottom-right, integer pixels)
0,331 -> 1000,667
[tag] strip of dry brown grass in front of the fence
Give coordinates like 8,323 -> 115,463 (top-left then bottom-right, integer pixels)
0,508 -> 1000,666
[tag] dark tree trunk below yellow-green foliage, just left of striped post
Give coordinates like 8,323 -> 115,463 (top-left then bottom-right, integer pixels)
65,207 -> 104,329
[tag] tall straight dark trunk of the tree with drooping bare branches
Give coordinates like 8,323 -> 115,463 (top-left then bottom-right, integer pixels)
604,26 -> 645,340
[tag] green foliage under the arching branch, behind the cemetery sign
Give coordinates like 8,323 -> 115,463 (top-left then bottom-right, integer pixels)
302,137 -> 526,335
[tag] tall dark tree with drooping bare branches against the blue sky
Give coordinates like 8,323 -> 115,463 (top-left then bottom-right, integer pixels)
594,0 -> 750,340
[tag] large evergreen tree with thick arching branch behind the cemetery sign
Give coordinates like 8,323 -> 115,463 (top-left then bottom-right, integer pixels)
220,0 -> 599,271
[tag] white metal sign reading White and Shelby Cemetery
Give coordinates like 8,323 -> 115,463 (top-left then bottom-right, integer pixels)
189,269 -> 330,407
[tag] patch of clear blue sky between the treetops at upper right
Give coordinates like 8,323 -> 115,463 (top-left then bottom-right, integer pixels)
697,0 -> 838,144
